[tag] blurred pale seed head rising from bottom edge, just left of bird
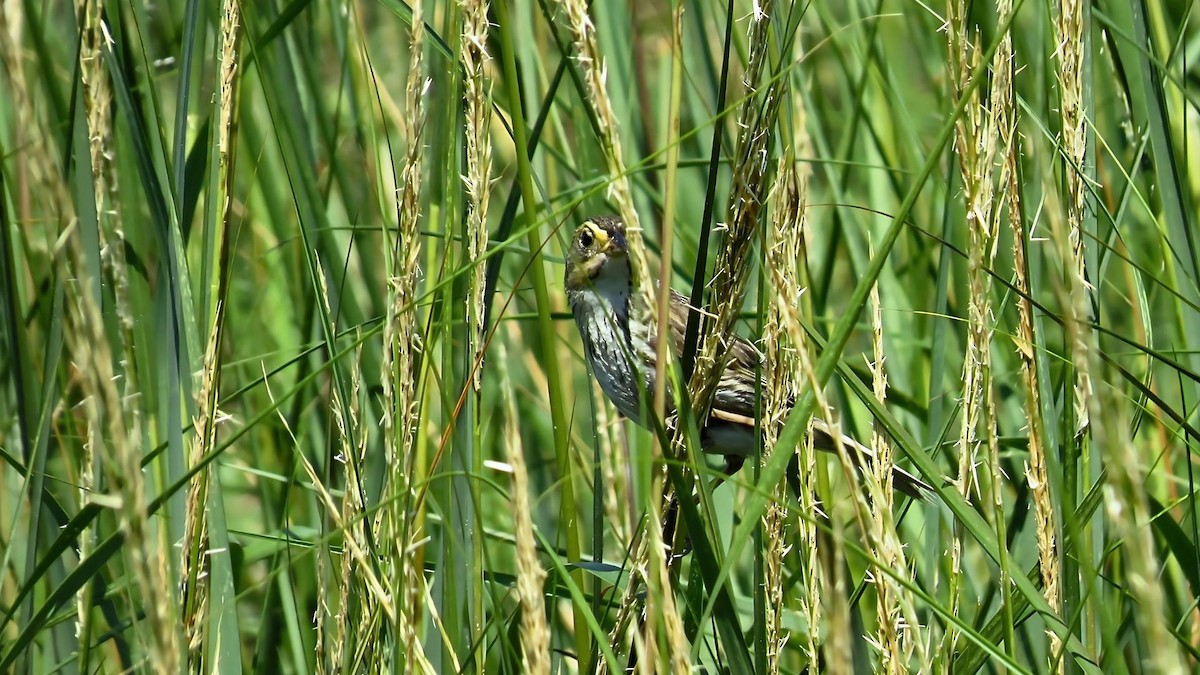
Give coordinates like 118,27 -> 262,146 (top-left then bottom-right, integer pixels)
496,330 -> 551,675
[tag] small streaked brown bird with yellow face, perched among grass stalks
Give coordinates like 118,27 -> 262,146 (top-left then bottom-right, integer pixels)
563,215 -> 932,500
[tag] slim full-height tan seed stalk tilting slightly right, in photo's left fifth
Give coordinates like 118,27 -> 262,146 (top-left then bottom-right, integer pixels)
180,0 -> 241,670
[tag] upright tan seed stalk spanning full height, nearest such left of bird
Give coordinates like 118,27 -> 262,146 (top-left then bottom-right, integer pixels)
377,0 -> 432,673
